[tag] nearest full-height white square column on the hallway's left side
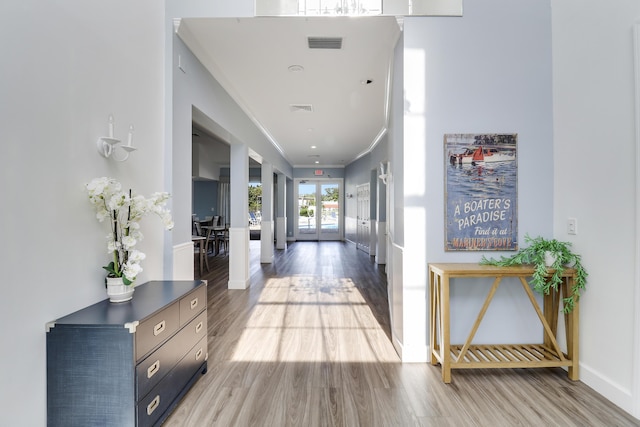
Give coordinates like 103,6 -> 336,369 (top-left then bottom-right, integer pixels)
228,143 -> 250,289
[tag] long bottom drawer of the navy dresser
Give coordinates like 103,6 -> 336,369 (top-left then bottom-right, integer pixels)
137,338 -> 207,426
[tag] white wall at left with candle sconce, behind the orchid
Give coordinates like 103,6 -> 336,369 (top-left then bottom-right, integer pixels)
0,0 -> 165,426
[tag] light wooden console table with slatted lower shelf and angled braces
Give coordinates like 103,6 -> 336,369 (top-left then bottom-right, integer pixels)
429,263 -> 579,383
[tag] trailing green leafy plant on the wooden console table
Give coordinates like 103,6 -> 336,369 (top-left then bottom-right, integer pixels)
480,234 -> 587,313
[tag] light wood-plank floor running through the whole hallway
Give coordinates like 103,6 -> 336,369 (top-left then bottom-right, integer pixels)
165,241 -> 640,427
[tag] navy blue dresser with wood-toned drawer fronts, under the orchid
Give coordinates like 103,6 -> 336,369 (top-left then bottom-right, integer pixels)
47,280 -> 208,427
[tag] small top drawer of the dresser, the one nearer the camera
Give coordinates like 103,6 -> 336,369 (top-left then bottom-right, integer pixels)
136,302 -> 180,360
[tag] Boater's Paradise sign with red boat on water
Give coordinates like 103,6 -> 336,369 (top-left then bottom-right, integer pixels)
444,134 -> 518,251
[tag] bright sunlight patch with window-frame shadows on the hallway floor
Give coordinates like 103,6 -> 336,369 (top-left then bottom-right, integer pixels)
232,275 -> 398,362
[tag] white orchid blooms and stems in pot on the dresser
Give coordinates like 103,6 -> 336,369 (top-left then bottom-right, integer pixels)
85,177 -> 173,285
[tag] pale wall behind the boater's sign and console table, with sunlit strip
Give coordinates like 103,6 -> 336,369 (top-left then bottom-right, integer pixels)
394,0 -> 553,360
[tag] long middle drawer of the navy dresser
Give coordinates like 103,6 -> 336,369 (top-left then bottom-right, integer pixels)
136,311 -> 207,400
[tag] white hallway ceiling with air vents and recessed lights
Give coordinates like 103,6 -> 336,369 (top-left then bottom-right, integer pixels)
178,17 -> 400,167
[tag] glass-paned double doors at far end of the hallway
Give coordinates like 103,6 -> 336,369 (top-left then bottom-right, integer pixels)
294,179 -> 343,240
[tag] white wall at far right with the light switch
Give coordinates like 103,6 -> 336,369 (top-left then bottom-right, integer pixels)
551,0 -> 640,418
